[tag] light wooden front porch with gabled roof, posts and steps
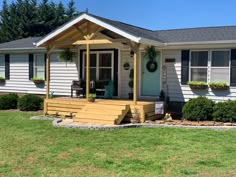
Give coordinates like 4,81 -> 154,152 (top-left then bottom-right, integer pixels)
37,14 -> 164,125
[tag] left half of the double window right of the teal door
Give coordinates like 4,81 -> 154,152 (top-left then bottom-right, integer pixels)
190,51 -> 208,82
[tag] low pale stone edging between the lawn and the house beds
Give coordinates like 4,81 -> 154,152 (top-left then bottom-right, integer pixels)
30,116 -> 236,130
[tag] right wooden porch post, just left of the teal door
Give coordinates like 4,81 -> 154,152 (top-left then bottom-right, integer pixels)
133,44 -> 139,105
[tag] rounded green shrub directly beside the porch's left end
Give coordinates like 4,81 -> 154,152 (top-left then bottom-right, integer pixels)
18,94 -> 43,111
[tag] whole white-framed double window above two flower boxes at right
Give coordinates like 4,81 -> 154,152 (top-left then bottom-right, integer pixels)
189,50 -> 230,83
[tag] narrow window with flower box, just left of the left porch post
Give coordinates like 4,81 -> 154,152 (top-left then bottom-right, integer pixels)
34,54 -> 45,79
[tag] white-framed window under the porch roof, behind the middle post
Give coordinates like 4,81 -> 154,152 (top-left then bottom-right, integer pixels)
83,51 -> 113,80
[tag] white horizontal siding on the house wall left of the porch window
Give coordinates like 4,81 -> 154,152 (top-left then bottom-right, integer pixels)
0,54 -> 78,95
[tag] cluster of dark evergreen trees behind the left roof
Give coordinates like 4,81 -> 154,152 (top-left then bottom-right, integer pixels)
0,0 -> 78,42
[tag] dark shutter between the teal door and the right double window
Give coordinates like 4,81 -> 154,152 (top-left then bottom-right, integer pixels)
181,50 -> 190,85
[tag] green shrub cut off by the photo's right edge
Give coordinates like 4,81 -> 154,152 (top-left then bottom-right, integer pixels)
212,100 -> 236,122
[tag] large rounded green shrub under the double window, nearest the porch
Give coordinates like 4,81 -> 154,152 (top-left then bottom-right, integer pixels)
182,97 -> 214,121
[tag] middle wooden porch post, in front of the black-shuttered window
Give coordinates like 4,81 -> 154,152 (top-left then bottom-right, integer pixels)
86,43 -> 90,101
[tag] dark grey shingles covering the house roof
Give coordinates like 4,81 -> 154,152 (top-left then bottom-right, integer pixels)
0,14 -> 236,50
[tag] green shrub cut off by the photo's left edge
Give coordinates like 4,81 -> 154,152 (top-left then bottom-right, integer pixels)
0,93 -> 18,110
